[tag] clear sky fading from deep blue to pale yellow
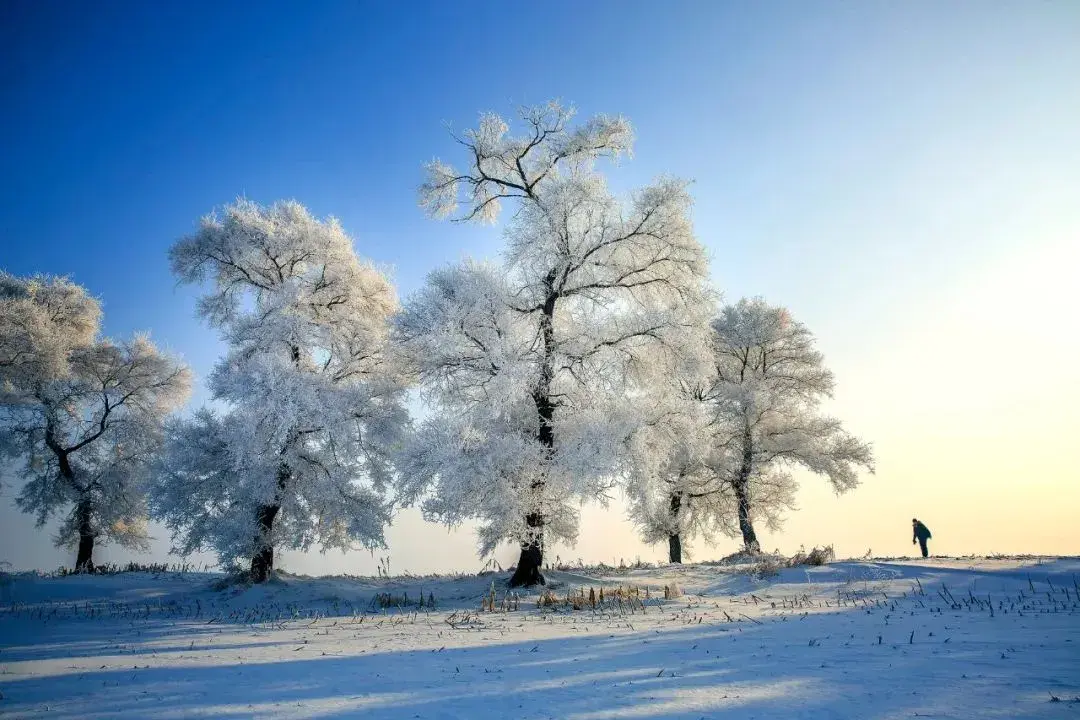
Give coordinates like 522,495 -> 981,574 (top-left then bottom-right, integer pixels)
0,0 -> 1080,573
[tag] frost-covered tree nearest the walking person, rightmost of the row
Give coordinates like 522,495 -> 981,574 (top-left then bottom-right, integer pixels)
710,298 -> 874,552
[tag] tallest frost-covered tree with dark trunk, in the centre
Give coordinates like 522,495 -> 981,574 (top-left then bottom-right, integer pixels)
399,103 -> 706,585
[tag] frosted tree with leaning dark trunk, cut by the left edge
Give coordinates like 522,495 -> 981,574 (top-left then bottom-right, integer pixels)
0,273 -> 191,570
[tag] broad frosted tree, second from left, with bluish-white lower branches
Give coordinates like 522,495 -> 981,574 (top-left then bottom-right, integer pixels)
152,200 -> 408,582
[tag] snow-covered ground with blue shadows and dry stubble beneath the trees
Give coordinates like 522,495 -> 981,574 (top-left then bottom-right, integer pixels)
0,558 -> 1080,720
